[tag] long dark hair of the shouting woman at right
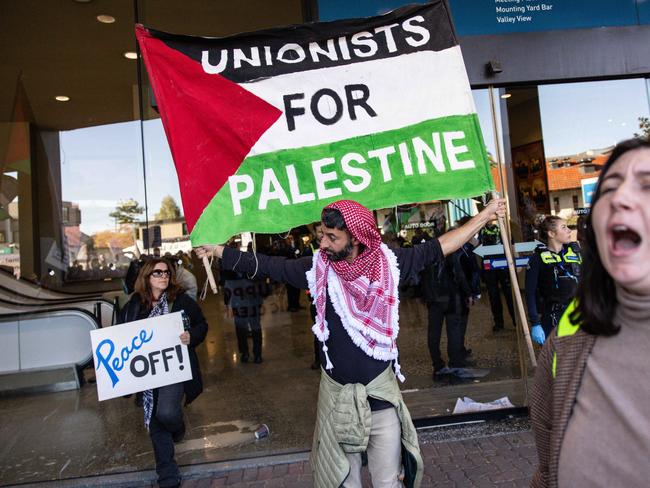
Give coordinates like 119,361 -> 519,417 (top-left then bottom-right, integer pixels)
570,139 -> 650,336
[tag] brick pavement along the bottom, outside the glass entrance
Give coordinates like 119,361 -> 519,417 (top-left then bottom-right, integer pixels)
6,419 -> 537,488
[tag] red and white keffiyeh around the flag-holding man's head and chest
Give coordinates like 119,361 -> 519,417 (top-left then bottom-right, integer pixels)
307,200 -> 404,381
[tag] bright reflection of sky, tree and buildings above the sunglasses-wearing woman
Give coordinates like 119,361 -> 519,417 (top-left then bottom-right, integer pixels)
60,122 -> 145,281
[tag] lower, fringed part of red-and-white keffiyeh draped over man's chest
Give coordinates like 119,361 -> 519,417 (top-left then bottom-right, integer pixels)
307,244 -> 406,382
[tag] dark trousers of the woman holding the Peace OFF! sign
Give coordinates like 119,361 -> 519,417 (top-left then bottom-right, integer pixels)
149,383 -> 185,488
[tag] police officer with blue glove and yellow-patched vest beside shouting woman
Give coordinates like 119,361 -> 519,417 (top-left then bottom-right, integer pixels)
526,215 -> 582,344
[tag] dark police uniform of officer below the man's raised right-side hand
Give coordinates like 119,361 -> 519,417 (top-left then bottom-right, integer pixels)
478,224 -> 515,330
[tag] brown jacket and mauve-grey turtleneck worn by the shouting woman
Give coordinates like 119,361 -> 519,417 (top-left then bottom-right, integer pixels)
530,290 -> 650,488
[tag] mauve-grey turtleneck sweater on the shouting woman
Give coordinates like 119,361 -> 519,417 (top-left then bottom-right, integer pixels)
558,289 -> 650,487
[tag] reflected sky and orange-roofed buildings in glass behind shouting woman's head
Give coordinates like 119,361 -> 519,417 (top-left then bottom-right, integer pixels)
539,79 -> 649,219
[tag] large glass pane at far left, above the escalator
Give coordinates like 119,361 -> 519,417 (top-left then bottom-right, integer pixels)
0,2 -> 144,286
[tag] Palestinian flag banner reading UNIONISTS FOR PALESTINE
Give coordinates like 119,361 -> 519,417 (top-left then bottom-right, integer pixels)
136,0 -> 494,246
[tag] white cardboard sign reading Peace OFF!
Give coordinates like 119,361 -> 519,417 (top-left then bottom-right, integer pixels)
90,312 -> 192,401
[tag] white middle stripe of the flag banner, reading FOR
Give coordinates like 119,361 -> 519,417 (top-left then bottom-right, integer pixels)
241,46 -> 476,156
